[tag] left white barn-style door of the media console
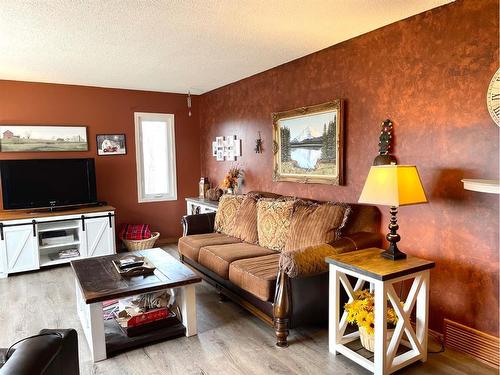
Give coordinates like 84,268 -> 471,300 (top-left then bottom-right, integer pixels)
0,225 -> 40,273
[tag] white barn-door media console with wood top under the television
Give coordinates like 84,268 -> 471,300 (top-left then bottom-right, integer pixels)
0,206 -> 116,278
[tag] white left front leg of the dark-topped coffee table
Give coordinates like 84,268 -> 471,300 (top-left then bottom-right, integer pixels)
76,281 -> 106,362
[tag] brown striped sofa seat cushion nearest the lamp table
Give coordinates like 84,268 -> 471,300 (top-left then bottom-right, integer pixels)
229,254 -> 280,301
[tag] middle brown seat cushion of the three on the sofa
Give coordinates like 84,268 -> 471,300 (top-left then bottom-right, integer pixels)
198,242 -> 275,279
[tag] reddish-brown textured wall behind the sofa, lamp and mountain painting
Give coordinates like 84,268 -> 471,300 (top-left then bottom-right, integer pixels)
200,0 -> 499,336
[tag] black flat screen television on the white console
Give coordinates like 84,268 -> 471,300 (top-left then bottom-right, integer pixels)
0,159 -> 97,210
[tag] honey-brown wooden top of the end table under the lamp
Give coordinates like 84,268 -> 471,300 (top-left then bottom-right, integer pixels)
325,247 -> 435,281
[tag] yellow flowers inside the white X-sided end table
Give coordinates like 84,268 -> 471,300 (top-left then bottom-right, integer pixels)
345,289 -> 398,336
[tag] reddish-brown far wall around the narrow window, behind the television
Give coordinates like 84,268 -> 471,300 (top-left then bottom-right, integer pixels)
0,81 -> 200,242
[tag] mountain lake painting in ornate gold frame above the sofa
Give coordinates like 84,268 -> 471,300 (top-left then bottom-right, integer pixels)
272,99 -> 344,185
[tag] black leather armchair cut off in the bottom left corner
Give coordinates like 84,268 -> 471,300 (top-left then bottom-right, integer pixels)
0,329 -> 80,375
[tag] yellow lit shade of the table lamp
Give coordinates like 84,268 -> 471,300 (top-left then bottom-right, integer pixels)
359,165 -> 427,207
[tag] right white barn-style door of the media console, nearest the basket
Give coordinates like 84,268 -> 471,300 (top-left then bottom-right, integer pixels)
81,217 -> 115,257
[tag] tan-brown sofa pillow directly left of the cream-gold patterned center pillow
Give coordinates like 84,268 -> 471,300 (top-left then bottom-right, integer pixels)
229,194 -> 260,244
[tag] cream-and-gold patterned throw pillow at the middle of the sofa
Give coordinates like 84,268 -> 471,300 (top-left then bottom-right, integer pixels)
257,199 -> 294,251
